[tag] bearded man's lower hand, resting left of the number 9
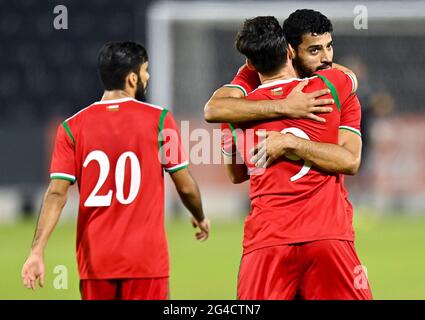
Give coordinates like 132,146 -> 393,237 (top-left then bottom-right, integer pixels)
250,131 -> 295,168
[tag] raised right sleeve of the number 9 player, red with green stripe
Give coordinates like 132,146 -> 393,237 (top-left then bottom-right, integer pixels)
316,69 -> 354,110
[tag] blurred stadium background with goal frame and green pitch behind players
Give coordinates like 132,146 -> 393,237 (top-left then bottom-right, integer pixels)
0,0 -> 425,299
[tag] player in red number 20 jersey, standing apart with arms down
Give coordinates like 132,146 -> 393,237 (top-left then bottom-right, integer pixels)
22,42 -> 209,300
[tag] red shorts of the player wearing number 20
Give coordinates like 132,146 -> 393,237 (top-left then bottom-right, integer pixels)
80,278 -> 168,300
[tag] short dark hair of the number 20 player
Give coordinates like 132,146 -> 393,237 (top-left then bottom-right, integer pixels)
97,41 -> 148,90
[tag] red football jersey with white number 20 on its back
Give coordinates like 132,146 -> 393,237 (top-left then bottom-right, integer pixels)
50,98 -> 188,279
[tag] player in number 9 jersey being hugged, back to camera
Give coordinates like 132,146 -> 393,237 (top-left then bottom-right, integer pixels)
220,17 -> 372,299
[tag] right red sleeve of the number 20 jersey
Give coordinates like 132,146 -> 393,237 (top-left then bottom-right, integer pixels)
160,112 -> 189,173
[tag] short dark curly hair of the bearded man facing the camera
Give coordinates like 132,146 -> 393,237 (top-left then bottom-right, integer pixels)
283,9 -> 333,48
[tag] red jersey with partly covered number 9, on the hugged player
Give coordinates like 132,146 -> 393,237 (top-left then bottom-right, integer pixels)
227,69 -> 360,253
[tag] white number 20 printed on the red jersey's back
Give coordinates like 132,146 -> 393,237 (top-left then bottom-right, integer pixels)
83,150 -> 140,207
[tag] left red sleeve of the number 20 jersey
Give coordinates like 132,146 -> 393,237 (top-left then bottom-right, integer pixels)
50,122 -> 77,183
